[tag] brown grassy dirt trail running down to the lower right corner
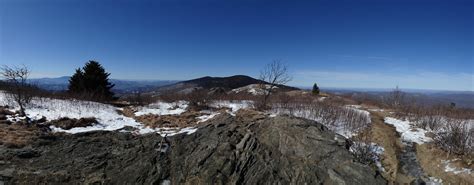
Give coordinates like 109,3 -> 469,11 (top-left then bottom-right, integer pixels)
369,108 -> 474,185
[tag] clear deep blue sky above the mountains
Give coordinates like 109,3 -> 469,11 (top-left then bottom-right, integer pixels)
0,0 -> 474,91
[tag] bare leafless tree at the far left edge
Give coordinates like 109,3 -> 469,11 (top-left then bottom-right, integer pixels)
0,65 -> 33,119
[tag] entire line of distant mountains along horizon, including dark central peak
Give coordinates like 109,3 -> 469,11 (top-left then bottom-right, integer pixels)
22,75 -> 474,108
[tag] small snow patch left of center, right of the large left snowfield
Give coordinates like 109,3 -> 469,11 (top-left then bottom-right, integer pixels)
135,101 -> 188,116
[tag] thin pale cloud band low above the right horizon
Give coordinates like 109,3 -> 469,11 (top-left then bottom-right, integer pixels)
294,71 -> 474,91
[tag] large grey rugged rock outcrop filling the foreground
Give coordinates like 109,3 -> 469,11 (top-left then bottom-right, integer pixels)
0,112 -> 386,184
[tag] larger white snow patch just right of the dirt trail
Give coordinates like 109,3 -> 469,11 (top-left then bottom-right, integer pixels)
385,117 -> 432,144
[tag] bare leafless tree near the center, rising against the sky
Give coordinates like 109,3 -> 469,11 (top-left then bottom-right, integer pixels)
258,60 -> 292,109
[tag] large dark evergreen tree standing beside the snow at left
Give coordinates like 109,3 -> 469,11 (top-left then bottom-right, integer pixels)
69,60 -> 114,100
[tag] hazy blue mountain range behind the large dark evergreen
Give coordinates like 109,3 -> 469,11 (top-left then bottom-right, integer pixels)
30,76 -> 179,93
